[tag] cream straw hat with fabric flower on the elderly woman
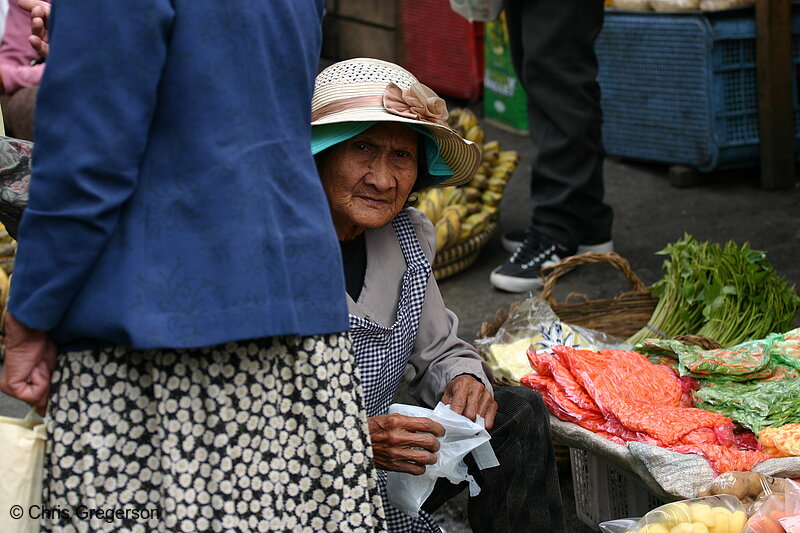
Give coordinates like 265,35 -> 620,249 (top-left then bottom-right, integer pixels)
311,58 -> 481,187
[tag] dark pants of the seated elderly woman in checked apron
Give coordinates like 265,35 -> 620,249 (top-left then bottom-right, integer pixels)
422,387 -> 566,533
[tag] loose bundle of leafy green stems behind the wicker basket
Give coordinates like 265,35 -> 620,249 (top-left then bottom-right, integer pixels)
628,234 -> 800,347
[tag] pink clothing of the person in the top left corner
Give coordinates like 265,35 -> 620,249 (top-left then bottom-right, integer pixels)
0,0 -> 44,93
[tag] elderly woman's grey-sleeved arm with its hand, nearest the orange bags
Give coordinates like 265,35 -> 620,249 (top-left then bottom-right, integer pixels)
409,211 -> 494,425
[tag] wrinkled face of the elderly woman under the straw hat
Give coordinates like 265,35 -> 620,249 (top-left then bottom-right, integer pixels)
320,122 -> 420,241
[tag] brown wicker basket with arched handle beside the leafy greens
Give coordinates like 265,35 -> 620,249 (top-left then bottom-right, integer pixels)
542,253 -> 658,339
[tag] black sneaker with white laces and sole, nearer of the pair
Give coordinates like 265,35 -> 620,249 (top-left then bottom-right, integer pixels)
489,230 -> 572,292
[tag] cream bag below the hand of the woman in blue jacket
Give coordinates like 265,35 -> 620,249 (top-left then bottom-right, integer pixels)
0,408 -> 47,533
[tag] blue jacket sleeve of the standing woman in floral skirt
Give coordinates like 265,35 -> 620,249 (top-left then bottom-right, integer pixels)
9,0 -> 174,331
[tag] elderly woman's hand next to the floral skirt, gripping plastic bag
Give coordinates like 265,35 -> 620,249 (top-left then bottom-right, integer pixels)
368,414 -> 444,476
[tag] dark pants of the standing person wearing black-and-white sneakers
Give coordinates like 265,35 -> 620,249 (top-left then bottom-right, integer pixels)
505,0 -> 613,251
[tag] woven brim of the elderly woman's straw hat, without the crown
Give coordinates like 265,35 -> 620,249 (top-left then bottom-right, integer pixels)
311,106 -> 482,187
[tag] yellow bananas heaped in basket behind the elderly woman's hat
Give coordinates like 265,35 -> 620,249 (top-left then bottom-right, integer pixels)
413,108 -> 519,252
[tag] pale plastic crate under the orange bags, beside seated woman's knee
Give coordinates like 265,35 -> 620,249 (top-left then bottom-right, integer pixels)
569,448 -> 667,531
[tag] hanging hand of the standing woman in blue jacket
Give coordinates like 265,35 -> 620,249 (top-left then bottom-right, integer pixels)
0,312 -> 57,415
